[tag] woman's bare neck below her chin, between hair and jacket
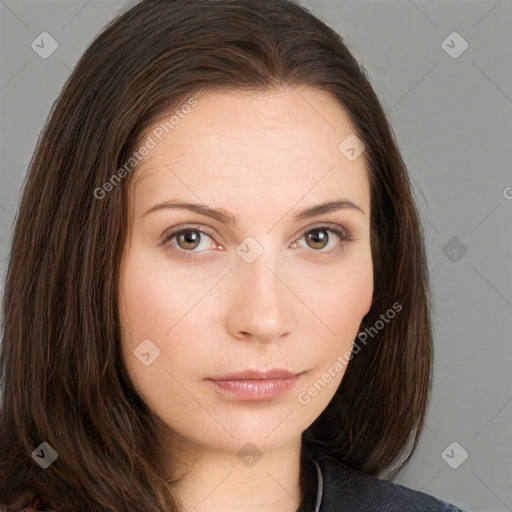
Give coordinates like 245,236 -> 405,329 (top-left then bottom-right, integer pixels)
166,437 -> 301,512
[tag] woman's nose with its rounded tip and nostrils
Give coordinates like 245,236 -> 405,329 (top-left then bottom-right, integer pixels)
225,247 -> 299,343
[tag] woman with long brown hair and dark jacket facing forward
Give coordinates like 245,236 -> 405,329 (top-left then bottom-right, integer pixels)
0,0 -> 466,512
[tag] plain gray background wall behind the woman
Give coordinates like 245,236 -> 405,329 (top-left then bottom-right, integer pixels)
0,0 -> 512,512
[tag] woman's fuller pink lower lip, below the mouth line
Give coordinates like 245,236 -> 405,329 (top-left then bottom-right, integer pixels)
208,375 -> 299,401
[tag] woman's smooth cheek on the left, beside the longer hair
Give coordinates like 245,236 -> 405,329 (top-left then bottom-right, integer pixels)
119,247 -> 224,404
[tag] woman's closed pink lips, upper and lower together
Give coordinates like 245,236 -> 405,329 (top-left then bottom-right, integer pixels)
206,368 -> 304,402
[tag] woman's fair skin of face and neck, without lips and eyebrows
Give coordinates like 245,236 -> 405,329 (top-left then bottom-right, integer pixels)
119,87 -> 373,512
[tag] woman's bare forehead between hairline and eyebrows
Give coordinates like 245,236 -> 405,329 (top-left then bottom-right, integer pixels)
128,88 -> 369,216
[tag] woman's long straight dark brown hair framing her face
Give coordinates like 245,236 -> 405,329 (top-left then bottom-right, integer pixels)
0,0 -> 431,512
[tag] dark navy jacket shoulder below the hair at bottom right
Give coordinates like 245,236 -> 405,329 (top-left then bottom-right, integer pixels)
315,446 -> 464,512
